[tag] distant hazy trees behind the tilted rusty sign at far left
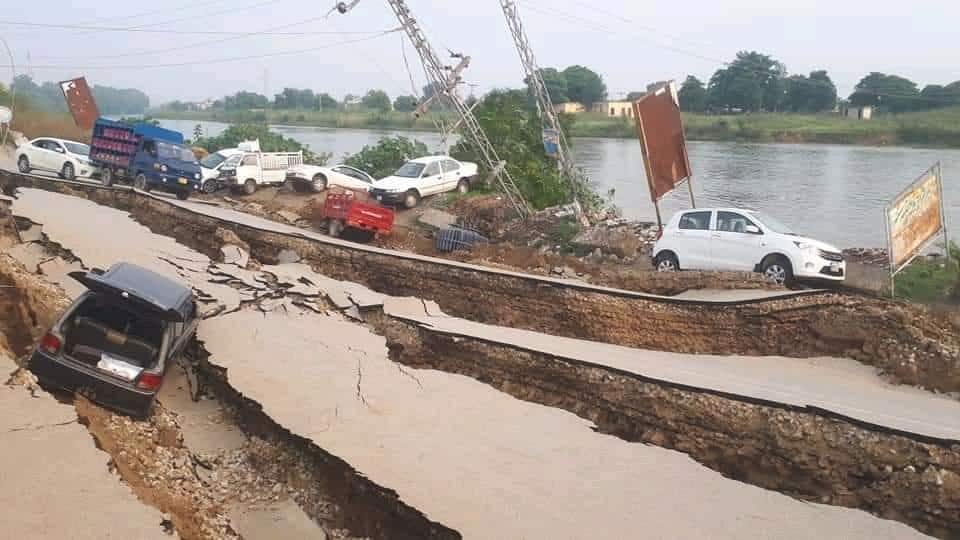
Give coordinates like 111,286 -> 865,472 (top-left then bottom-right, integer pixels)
12,75 -> 150,115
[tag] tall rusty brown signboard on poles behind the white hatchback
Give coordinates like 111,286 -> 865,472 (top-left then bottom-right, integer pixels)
633,81 -> 697,228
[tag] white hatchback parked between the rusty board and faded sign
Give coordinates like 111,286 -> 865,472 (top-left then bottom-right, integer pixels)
653,208 -> 846,283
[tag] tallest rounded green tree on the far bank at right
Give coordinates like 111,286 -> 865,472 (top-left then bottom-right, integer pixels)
707,51 -> 787,112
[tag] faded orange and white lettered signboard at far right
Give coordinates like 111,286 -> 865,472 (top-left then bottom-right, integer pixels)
887,163 -> 945,273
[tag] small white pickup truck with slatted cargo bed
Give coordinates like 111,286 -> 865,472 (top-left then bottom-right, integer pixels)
220,141 -> 303,195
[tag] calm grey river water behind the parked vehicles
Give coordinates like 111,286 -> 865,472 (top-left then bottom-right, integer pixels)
162,120 -> 960,247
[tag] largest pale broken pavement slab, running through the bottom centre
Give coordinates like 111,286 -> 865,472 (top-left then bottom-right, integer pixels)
200,305 -> 922,539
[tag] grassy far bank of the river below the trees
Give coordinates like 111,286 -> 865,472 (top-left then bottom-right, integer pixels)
152,107 -> 960,148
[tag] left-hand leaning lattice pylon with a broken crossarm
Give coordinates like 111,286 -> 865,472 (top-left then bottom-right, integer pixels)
336,0 -> 530,218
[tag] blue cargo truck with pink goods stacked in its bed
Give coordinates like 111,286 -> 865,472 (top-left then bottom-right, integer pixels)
90,118 -> 201,200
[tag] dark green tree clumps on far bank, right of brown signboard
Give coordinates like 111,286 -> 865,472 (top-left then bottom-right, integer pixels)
679,51 -> 960,113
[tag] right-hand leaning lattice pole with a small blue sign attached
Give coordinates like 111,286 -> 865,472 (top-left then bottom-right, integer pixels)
500,0 -> 590,226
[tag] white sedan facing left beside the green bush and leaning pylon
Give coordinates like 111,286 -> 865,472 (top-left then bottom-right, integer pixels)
370,156 -> 477,208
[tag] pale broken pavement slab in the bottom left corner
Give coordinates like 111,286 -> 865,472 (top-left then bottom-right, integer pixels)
0,385 -> 176,540
